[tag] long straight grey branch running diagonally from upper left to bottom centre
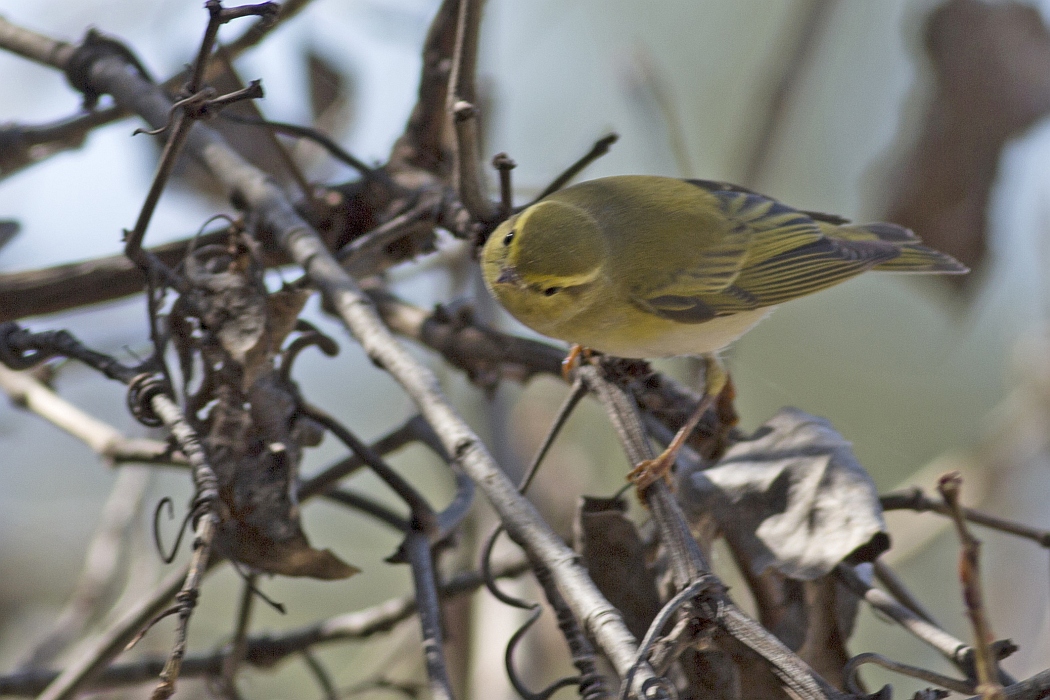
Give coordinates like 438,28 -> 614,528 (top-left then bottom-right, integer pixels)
0,15 -> 648,683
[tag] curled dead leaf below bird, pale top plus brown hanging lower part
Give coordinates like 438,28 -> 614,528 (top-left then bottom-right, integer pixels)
680,408 -> 889,697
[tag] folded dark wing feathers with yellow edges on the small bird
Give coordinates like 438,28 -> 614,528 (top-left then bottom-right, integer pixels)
637,181 -> 900,323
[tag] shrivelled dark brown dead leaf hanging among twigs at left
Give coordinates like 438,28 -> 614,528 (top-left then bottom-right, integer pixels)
176,242 -> 357,579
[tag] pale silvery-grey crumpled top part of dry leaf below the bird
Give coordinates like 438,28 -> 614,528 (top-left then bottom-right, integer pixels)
681,408 -> 889,580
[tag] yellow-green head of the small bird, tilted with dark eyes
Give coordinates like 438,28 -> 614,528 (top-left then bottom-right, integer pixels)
481,201 -> 606,338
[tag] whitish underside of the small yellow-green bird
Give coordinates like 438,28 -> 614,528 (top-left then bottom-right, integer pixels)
580,306 -> 774,358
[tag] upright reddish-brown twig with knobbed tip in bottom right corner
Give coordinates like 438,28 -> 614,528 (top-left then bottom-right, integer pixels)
937,471 -> 1003,700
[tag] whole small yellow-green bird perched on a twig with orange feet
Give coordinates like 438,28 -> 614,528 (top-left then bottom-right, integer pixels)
480,175 -> 968,490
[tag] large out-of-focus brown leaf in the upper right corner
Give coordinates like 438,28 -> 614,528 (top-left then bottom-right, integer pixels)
887,0 -> 1050,285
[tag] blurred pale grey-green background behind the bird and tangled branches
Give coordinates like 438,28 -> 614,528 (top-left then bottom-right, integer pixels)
0,0 -> 1050,698
